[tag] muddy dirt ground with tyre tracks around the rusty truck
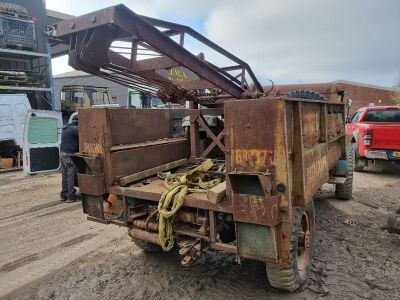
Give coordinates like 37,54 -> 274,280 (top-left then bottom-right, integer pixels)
0,168 -> 400,299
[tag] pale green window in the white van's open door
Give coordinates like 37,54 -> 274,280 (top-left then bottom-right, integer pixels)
28,117 -> 58,144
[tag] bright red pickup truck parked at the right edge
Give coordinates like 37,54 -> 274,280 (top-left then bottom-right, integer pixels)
346,106 -> 400,172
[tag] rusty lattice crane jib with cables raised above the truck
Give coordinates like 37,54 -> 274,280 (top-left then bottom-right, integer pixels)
54,5 -> 264,105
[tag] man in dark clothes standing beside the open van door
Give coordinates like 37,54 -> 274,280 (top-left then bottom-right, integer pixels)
60,114 -> 79,203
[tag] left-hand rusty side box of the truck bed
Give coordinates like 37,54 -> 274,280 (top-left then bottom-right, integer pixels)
74,108 -> 189,195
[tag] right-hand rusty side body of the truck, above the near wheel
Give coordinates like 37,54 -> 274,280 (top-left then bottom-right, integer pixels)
225,98 -> 345,263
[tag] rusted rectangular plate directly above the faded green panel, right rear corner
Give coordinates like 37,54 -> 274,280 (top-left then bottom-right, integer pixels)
233,194 -> 279,226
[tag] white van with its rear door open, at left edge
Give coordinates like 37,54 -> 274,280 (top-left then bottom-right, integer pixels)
0,94 -> 62,175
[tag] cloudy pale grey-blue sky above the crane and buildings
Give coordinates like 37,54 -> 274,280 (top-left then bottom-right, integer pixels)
46,0 -> 400,86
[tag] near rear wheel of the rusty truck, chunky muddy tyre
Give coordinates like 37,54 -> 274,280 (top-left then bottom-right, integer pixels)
266,200 -> 315,291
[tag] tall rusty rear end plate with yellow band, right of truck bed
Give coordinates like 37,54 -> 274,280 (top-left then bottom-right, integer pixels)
224,98 -> 291,209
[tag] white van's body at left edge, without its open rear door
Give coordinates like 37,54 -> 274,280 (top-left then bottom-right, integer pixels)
0,94 -> 31,162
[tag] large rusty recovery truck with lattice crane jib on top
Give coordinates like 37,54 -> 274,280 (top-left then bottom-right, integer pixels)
55,5 -> 353,291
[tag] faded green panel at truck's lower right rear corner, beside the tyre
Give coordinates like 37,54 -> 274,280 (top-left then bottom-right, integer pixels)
236,222 -> 277,258
